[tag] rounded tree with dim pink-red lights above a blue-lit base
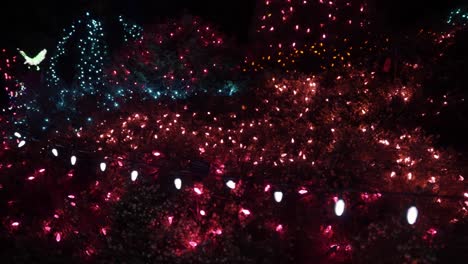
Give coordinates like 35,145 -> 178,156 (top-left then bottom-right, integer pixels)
107,16 -> 240,105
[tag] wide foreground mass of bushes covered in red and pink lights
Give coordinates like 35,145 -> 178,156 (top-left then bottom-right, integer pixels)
1,63 -> 466,263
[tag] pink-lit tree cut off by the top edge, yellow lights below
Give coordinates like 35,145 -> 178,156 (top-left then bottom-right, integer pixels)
246,0 -> 374,71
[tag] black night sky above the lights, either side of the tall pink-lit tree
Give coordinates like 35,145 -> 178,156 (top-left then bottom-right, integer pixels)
0,0 -> 464,49
